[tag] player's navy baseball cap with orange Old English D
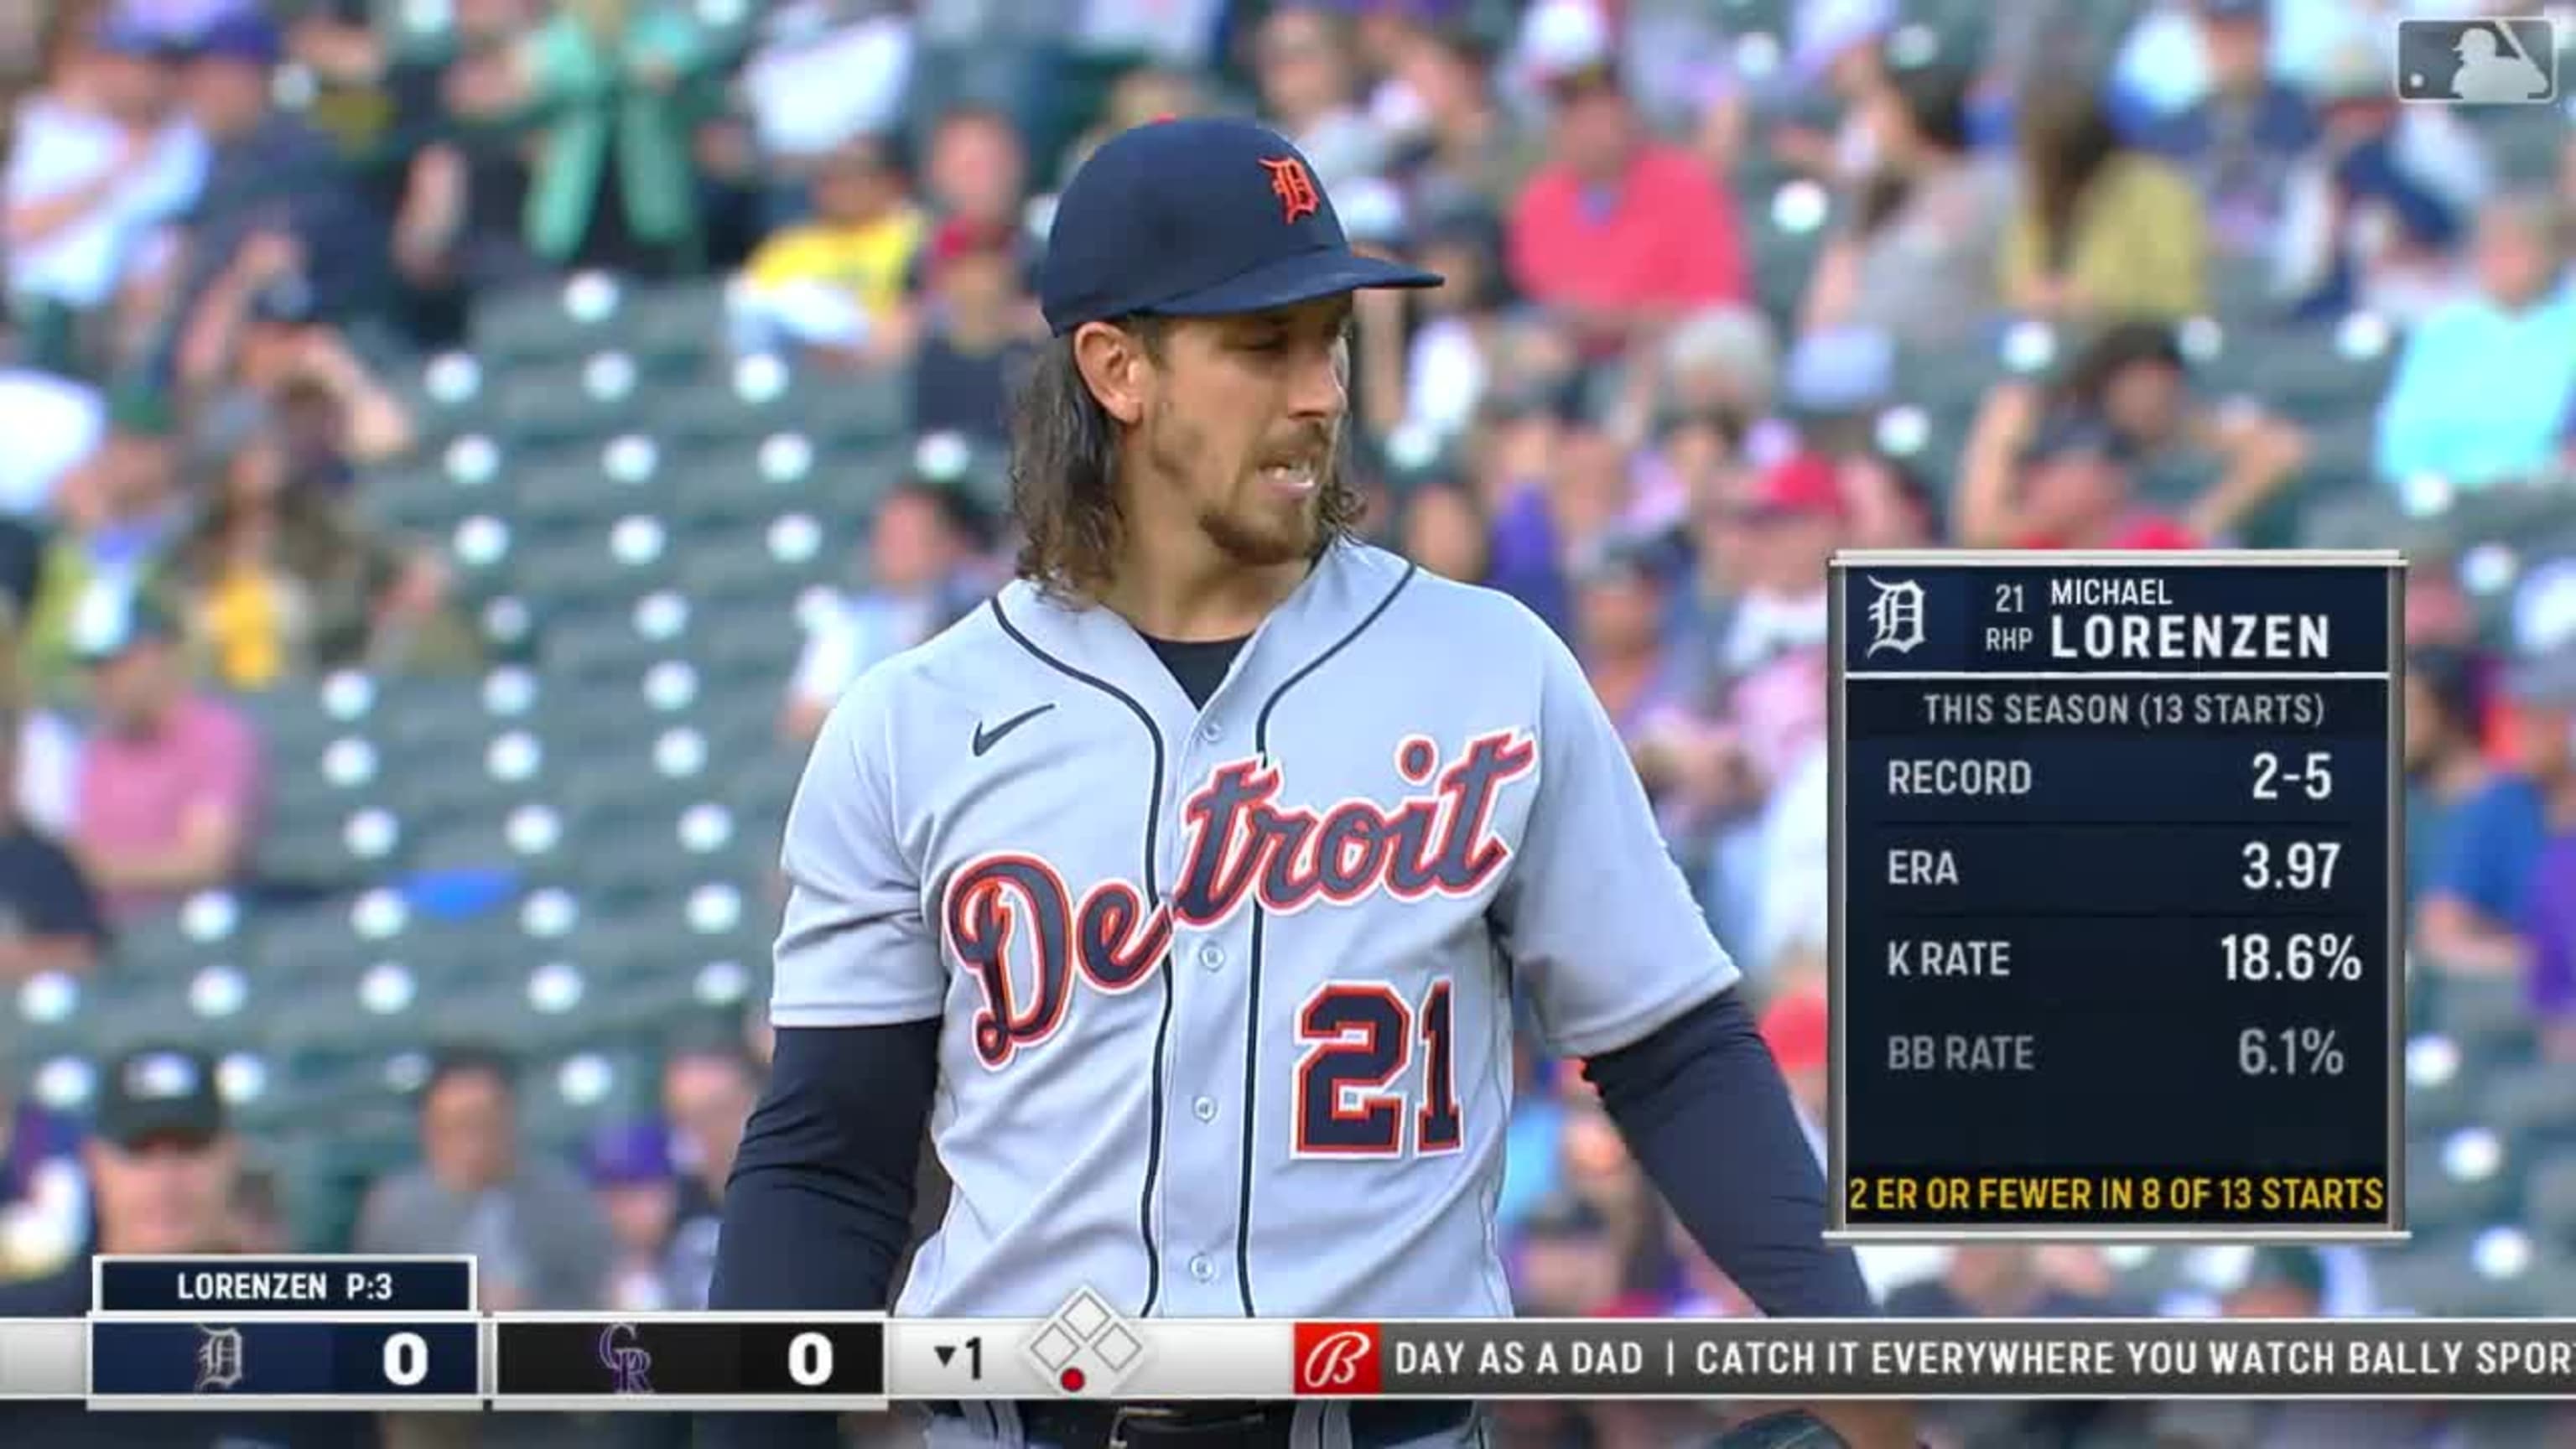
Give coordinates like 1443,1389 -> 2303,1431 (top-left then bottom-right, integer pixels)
1038,116 -> 1442,338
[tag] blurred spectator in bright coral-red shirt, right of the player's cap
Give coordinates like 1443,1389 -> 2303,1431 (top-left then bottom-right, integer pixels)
1509,65 -> 1749,356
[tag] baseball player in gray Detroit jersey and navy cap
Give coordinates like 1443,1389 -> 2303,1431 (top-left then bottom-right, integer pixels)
714,118 -> 1911,1449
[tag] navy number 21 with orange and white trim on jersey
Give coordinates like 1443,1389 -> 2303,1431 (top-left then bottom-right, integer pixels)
1293,977 -> 1463,1158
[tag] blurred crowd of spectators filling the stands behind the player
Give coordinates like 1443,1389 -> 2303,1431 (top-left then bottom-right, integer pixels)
0,0 -> 2576,1444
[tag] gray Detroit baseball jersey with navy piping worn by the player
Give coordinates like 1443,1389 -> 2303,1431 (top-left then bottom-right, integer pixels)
771,544 -> 1737,1317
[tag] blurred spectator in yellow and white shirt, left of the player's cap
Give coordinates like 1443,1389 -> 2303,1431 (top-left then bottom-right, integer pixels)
731,139 -> 927,366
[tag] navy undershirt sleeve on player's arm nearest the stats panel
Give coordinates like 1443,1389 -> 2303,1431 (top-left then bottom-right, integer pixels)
1584,990 -> 1877,1317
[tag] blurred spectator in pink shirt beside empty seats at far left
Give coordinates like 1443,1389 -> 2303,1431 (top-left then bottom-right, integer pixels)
72,593 -> 260,921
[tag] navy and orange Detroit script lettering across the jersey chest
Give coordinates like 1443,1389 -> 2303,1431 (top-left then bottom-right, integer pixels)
940,730 -> 1538,1067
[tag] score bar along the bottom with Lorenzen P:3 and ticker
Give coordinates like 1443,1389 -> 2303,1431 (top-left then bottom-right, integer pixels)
15,1258 -> 2576,1426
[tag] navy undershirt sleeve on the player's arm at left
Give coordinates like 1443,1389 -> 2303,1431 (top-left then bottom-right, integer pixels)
699,1021 -> 940,1449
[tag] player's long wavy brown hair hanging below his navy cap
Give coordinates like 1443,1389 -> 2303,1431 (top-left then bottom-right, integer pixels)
1010,317 -> 1368,600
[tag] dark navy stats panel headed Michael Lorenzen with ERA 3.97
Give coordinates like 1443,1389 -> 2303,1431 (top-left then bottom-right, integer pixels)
1829,552 -> 2406,1240
